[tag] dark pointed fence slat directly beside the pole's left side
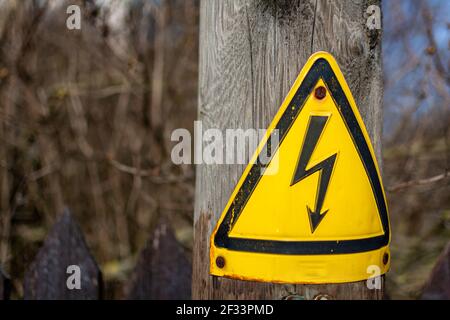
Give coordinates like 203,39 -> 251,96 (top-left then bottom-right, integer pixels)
127,219 -> 192,300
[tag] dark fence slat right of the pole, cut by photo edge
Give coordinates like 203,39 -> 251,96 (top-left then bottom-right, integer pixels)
422,243 -> 450,300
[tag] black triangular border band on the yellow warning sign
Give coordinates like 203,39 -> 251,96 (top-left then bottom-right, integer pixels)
214,58 -> 390,255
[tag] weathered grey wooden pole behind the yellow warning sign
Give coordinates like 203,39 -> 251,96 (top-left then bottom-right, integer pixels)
193,0 -> 383,299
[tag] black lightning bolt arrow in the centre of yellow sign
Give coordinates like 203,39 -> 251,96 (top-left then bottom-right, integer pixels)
291,116 -> 337,233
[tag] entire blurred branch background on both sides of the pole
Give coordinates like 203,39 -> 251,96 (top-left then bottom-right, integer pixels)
0,0 -> 450,299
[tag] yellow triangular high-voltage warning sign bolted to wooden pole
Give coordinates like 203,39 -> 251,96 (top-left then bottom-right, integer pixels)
210,52 -> 390,283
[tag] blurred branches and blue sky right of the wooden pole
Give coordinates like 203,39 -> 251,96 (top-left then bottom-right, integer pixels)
383,1 -> 450,299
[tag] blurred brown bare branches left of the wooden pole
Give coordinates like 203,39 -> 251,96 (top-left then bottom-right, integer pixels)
0,0 -> 198,298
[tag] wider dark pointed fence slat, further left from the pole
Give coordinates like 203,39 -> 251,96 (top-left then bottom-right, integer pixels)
24,209 -> 102,300
